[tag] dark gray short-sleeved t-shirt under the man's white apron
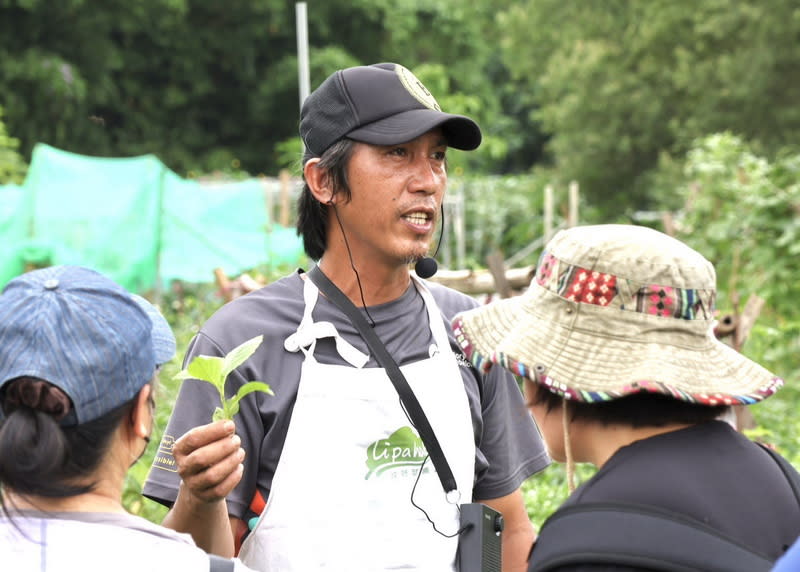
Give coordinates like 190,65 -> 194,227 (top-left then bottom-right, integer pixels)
144,272 -> 549,521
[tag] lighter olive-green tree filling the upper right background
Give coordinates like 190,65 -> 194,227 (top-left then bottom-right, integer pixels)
501,0 -> 800,209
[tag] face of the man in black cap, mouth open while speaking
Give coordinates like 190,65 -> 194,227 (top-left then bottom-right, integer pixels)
337,128 -> 447,268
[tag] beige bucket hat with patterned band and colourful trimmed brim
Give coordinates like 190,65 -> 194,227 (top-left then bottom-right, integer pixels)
453,225 -> 783,405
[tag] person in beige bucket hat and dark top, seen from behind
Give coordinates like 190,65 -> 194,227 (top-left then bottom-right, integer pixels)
453,225 -> 800,571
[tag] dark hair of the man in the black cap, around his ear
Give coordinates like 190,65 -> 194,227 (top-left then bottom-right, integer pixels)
297,138 -> 355,260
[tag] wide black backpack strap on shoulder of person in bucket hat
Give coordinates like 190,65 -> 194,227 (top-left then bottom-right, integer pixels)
529,503 -> 772,572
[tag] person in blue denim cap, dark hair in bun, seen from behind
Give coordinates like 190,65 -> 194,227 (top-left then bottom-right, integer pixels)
0,266 -> 253,572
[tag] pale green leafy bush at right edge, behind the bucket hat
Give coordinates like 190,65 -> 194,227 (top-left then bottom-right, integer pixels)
675,133 -> 800,320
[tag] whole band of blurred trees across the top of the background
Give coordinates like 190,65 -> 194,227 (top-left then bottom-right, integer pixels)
0,0 -> 800,213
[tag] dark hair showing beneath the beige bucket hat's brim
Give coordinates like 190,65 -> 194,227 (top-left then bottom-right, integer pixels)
528,381 -> 727,428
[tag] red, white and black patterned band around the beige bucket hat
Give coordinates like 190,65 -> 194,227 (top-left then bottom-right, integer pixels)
535,252 -> 716,320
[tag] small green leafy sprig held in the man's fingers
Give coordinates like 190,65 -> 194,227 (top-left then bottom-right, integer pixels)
175,336 -> 274,421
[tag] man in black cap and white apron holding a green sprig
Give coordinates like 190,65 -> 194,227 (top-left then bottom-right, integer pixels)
145,63 -> 548,571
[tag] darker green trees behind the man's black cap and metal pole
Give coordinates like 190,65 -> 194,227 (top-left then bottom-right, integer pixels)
0,0 -> 538,174
